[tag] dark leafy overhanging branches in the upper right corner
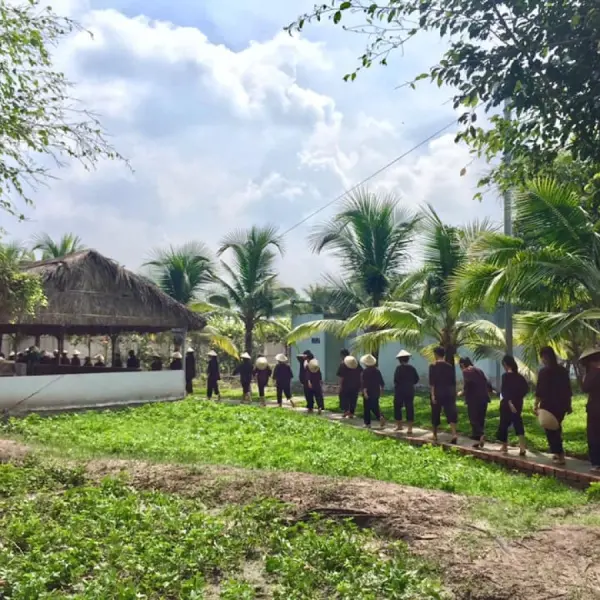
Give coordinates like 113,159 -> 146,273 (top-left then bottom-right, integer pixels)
287,0 -> 600,192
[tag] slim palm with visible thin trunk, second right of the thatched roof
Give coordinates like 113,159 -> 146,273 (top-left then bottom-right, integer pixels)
209,226 -> 289,353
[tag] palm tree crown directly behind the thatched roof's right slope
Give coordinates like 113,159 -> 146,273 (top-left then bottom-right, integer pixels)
144,242 -> 216,304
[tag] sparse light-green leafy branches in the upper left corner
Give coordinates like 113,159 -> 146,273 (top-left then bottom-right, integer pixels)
0,0 -> 123,217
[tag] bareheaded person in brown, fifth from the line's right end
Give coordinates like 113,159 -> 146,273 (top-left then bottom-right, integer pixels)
429,346 -> 458,444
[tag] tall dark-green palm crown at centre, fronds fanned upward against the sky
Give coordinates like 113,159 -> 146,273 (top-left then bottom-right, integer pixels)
310,189 -> 419,313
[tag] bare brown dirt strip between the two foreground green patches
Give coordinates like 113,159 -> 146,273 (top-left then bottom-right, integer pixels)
0,440 -> 600,600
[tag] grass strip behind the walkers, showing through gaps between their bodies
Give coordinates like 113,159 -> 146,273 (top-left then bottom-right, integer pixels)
213,386 -> 587,458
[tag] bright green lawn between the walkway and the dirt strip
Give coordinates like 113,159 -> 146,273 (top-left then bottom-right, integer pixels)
9,400 -> 587,510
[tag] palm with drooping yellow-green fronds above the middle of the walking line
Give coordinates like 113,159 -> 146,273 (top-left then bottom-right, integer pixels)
289,207 -> 504,364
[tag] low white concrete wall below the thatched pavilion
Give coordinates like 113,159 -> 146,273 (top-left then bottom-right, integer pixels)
0,371 -> 185,415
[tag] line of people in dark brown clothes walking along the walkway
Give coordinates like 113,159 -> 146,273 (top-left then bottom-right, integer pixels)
207,346 -> 600,472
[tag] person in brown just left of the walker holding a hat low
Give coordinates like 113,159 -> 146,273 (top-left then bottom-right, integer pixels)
496,354 -> 529,456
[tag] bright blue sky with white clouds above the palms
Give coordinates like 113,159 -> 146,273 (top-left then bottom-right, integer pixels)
8,0 -> 500,287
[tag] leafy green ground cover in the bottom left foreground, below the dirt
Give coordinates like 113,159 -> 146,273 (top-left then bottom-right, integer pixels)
0,464 -> 442,600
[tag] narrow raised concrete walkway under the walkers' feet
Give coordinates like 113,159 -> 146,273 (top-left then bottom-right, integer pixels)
222,397 -> 600,487
